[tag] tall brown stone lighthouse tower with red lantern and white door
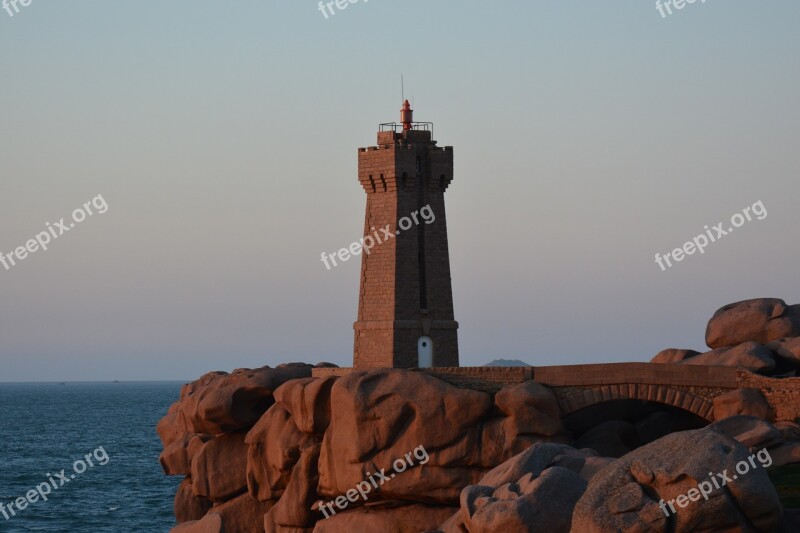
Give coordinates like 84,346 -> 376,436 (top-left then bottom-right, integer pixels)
353,100 -> 458,368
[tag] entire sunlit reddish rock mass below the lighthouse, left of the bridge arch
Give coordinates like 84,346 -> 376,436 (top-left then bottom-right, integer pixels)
159,365 -> 564,533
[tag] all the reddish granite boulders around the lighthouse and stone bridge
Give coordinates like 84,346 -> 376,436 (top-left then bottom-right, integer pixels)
158,299 -> 800,533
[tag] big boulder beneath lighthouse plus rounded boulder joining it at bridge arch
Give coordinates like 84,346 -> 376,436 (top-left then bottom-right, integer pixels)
312,370 -> 565,505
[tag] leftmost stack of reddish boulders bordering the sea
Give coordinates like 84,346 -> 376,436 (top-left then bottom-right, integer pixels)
157,363 -> 313,533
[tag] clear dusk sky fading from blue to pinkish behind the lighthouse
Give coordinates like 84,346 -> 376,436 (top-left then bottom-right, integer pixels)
0,0 -> 800,381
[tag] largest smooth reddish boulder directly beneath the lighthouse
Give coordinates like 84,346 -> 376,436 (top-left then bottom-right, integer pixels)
319,370 -> 494,503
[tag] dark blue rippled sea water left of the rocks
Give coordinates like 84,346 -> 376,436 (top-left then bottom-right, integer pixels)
0,382 -> 182,533
